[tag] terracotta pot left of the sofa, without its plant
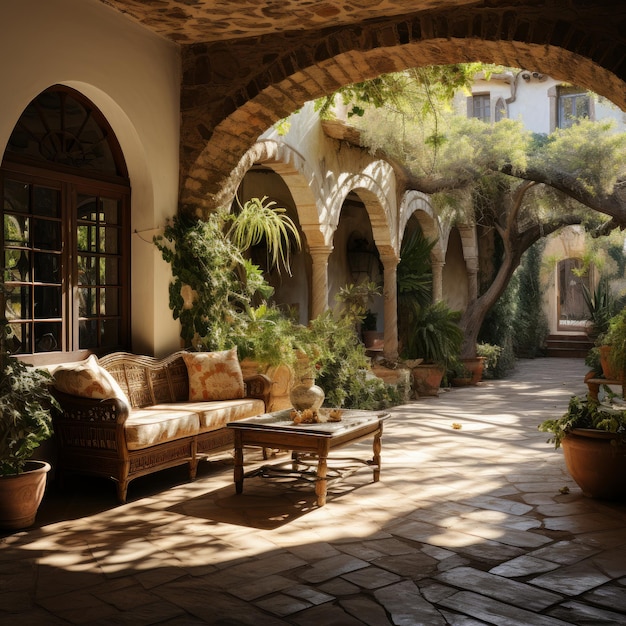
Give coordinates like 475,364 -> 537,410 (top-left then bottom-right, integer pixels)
0,461 -> 50,530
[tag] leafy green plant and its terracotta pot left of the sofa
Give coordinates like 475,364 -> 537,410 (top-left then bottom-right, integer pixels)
0,319 -> 58,530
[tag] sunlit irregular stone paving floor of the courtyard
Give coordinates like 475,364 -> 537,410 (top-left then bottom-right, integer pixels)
0,359 -> 626,626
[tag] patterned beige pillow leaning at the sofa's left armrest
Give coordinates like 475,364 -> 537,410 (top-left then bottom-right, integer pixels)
53,354 -> 129,406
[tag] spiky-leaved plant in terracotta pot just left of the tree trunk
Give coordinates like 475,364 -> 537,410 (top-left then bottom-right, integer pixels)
404,302 -> 463,396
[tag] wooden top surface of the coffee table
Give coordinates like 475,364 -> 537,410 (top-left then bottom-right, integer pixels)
227,409 -> 389,437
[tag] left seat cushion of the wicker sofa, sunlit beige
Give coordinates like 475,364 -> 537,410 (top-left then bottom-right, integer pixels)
124,404 -> 200,450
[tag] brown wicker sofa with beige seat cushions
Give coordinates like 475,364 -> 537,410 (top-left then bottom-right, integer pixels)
53,351 -> 271,503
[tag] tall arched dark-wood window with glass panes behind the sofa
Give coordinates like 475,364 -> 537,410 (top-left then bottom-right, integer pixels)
0,86 -> 130,355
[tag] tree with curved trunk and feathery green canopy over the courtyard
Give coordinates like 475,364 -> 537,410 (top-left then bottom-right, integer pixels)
324,68 -> 626,356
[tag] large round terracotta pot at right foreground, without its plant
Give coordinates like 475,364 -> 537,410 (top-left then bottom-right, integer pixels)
561,428 -> 626,500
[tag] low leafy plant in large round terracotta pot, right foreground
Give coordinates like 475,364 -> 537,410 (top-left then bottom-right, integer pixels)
539,396 -> 626,500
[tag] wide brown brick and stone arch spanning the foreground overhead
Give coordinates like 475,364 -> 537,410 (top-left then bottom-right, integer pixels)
181,3 -> 626,209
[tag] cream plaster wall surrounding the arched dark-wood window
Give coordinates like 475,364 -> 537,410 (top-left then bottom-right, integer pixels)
0,0 -> 180,354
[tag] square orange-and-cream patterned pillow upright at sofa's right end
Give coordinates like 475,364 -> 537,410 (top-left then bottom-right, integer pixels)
183,348 -> 244,401
